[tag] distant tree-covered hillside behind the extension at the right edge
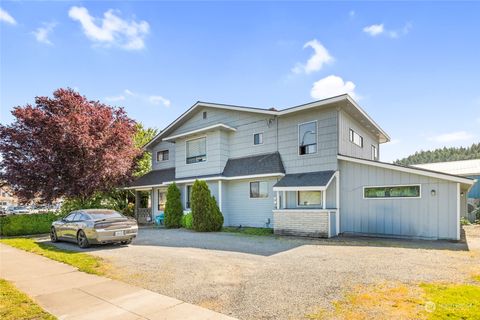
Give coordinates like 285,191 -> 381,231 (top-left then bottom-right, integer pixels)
395,143 -> 480,165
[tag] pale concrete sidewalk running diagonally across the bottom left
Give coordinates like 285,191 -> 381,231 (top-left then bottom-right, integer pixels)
0,244 -> 234,320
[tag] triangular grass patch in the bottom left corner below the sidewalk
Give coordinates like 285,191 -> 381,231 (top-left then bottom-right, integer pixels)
0,279 -> 56,320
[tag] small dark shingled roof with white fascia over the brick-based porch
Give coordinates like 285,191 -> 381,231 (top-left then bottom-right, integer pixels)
273,170 -> 335,191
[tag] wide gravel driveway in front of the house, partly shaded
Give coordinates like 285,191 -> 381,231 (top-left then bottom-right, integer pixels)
47,228 -> 480,319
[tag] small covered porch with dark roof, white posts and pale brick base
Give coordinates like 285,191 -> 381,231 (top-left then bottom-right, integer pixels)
273,171 -> 340,238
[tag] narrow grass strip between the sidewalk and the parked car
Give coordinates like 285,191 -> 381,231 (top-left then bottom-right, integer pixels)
0,238 -> 108,275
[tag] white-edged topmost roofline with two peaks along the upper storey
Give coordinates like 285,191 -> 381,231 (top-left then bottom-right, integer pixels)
144,94 -> 390,148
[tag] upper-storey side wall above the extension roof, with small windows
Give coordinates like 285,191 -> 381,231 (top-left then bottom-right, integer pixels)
338,110 -> 380,160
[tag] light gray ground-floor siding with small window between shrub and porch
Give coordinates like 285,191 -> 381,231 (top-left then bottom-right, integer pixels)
223,178 -> 278,227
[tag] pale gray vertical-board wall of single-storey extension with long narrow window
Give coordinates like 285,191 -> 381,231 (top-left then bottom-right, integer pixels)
340,161 -> 457,239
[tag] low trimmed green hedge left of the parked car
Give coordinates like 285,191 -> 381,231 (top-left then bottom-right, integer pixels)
0,213 -> 61,236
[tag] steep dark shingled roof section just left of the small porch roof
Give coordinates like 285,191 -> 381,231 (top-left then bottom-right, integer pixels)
222,152 -> 285,177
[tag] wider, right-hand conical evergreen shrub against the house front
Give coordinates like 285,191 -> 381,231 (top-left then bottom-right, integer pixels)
191,180 -> 223,231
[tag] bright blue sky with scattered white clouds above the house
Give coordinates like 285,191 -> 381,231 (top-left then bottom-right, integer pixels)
0,1 -> 480,161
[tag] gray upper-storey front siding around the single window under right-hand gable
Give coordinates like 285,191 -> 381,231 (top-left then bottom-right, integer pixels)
278,108 -> 338,173
